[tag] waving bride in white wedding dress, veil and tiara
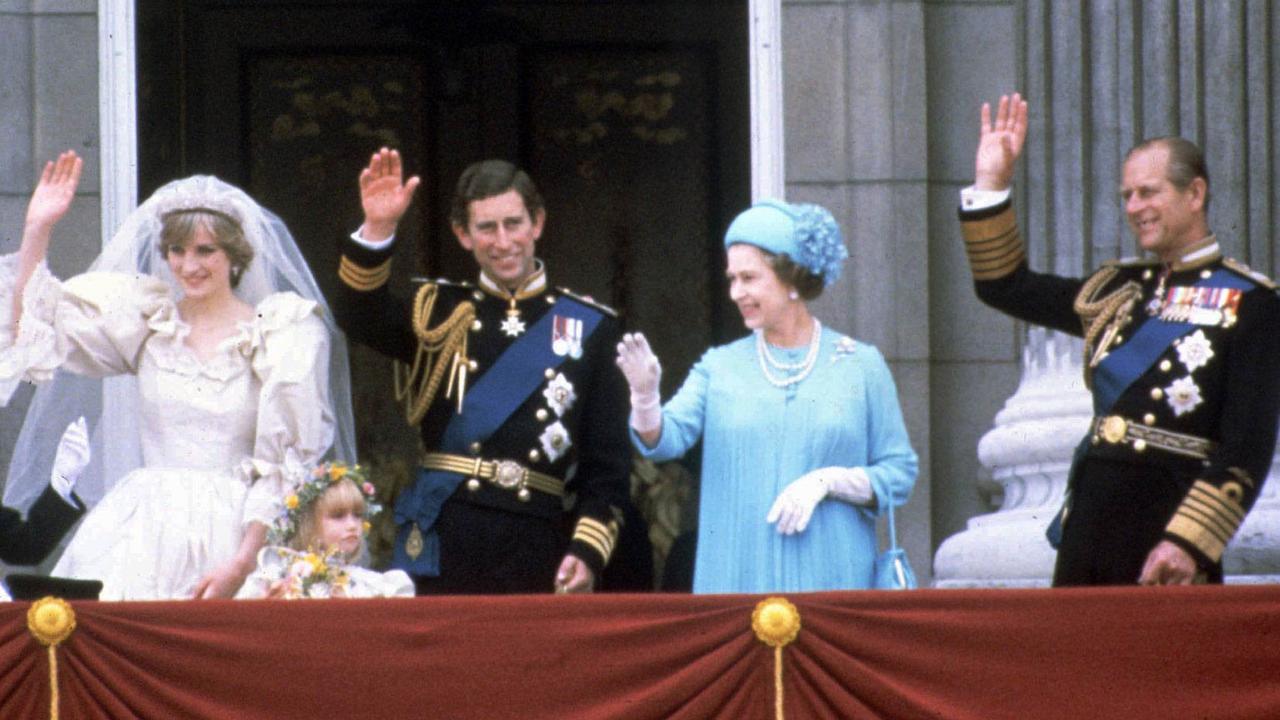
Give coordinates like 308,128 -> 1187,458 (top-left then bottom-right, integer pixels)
0,151 -> 355,600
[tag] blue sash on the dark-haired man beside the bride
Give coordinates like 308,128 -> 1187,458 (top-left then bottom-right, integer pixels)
392,295 -> 603,578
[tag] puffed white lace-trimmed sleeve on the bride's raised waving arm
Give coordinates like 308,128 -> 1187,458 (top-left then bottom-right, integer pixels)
0,255 -> 175,404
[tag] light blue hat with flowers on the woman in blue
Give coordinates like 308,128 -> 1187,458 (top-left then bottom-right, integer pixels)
724,200 -> 849,287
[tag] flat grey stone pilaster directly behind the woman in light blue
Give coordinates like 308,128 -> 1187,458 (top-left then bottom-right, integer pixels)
782,0 -> 932,582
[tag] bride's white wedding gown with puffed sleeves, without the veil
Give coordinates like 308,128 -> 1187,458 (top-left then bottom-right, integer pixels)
0,255 -> 334,600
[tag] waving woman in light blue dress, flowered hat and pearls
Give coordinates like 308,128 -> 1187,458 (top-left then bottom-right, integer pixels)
618,201 -> 916,593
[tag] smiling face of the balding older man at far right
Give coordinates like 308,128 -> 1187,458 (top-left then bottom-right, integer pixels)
1120,145 -> 1208,261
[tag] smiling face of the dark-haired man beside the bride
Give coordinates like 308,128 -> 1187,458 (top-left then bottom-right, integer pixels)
453,190 -> 545,291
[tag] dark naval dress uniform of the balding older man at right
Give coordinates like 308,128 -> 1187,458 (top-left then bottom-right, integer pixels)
960,200 -> 1280,585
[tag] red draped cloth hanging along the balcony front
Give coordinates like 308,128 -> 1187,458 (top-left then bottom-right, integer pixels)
0,585 -> 1280,720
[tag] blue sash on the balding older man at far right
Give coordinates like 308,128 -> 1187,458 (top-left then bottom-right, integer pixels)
1093,268 -> 1253,415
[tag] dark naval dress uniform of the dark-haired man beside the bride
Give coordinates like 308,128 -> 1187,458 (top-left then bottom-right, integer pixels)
333,233 -> 631,594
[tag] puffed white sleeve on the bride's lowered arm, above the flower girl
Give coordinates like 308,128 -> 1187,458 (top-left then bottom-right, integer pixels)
244,292 -> 334,525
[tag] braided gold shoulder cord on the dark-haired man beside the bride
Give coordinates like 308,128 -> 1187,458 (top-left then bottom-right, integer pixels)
393,283 -> 476,425
